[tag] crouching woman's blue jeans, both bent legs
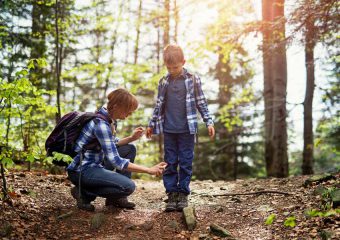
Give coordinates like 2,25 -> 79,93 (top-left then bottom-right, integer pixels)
68,144 -> 136,202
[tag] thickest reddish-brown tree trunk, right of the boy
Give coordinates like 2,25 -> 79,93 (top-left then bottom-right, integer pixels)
262,0 -> 288,177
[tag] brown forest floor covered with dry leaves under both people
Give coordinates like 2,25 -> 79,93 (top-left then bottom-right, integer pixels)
0,171 -> 340,240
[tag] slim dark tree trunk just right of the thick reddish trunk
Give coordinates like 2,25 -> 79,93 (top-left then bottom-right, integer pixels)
302,13 -> 315,175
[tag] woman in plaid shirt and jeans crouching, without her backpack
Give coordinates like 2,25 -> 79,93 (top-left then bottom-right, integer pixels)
67,89 -> 166,211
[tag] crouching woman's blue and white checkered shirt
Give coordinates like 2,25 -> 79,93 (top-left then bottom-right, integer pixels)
67,107 -> 129,171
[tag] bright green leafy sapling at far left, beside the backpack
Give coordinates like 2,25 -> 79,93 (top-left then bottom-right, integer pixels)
0,59 -> 56,167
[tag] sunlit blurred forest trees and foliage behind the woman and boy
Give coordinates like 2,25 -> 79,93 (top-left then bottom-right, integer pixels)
0,0 -> 340,183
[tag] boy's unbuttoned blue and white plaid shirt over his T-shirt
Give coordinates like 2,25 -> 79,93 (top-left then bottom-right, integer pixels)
149,69 -> 214,134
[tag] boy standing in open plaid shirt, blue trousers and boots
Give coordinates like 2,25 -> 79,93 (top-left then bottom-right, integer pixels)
146,45 -> 215,211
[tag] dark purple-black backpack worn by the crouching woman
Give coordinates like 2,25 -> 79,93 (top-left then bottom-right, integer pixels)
45,111 -> 112,166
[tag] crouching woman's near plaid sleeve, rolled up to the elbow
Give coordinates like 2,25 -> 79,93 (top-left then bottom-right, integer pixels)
94,120 -> 129,170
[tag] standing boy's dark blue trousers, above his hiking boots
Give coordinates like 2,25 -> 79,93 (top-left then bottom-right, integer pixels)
163,132 -> 195,195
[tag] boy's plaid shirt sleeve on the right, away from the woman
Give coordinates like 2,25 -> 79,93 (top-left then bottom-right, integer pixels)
194,75 -> 214,127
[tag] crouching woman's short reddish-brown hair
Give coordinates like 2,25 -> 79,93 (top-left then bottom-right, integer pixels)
107,88 -> 138,115
